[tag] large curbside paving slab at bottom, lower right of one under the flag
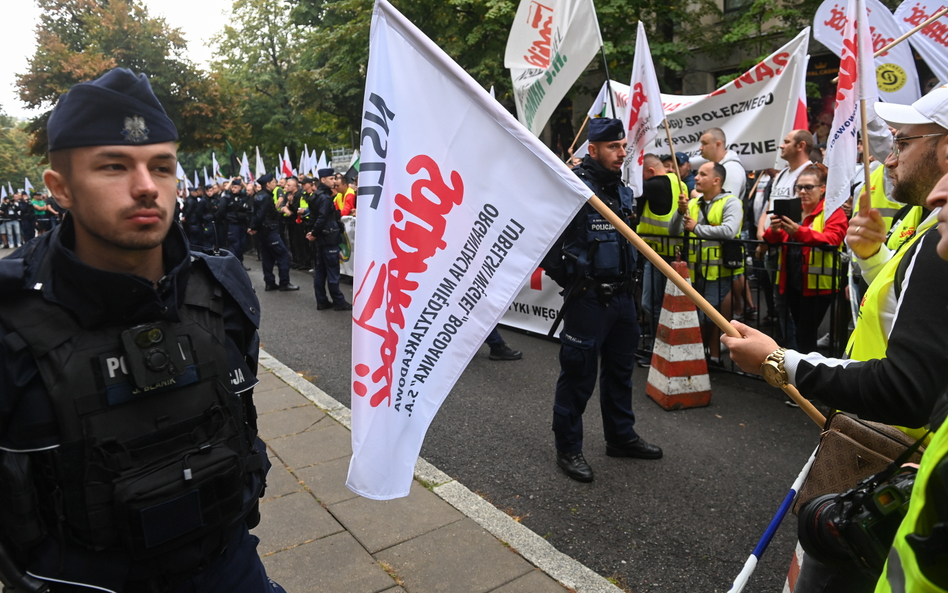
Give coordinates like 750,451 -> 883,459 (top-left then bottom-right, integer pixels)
375,518 -> 533,593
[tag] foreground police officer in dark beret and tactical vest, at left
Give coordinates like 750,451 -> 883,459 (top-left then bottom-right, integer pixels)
0,68 -> 282,593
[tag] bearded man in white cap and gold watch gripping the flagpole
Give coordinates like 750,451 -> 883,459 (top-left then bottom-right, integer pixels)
721,87 -> 948,593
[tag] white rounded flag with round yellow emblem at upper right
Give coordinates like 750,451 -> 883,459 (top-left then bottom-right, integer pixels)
813,0 -> 921,105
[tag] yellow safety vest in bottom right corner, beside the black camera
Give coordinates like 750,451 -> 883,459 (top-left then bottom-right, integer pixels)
876,427 -> 948,593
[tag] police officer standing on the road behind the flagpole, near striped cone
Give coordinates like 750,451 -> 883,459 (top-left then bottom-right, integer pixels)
543,118 -> 662,482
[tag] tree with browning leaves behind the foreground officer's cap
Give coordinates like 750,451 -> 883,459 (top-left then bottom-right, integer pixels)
17,0 -> 228,154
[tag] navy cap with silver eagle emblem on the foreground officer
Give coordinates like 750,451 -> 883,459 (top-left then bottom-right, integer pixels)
46,68 -> 178,152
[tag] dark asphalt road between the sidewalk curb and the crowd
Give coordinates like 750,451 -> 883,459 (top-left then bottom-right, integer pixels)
247,256 -> 819,593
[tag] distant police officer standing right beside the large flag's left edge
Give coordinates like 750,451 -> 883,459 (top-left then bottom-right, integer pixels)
306,167 -> 352,311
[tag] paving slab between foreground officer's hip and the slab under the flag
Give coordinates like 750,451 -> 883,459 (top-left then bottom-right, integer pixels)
254,491 -> 343,554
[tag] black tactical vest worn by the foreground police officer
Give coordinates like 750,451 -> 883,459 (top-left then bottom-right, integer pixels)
0,266 -> 263,580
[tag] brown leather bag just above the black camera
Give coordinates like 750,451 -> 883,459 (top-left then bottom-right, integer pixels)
793,412 -> 925,515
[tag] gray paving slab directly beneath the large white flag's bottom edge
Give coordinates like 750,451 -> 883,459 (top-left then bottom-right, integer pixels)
329,482 -> 464,554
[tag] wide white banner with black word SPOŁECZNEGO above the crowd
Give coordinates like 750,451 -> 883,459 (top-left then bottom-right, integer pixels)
589,27 -> 810,171
